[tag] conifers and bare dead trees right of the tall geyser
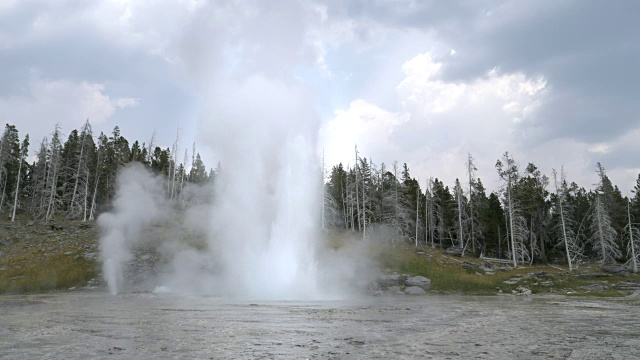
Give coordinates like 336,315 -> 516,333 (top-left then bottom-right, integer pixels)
322,146 -> 640,272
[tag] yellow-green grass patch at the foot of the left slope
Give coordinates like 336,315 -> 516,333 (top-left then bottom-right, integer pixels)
0,253 -> 96,294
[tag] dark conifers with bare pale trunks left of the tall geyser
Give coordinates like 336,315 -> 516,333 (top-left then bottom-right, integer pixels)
0,120 -> 215,221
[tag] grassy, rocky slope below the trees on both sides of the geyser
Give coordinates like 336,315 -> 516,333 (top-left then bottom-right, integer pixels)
0,218 -> 640,297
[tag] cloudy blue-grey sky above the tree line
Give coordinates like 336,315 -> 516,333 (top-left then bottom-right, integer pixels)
0,0 -> 640,194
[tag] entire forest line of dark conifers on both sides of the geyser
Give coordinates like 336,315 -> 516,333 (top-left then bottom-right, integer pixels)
0,120 -> 640,271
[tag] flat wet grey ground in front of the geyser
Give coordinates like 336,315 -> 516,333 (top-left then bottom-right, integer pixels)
0,292 -> 640,359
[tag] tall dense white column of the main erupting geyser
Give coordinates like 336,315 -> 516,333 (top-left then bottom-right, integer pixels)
205,76 -> 321,298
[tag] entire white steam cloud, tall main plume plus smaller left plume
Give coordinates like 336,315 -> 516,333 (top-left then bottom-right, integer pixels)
95,1 -> 376,299
